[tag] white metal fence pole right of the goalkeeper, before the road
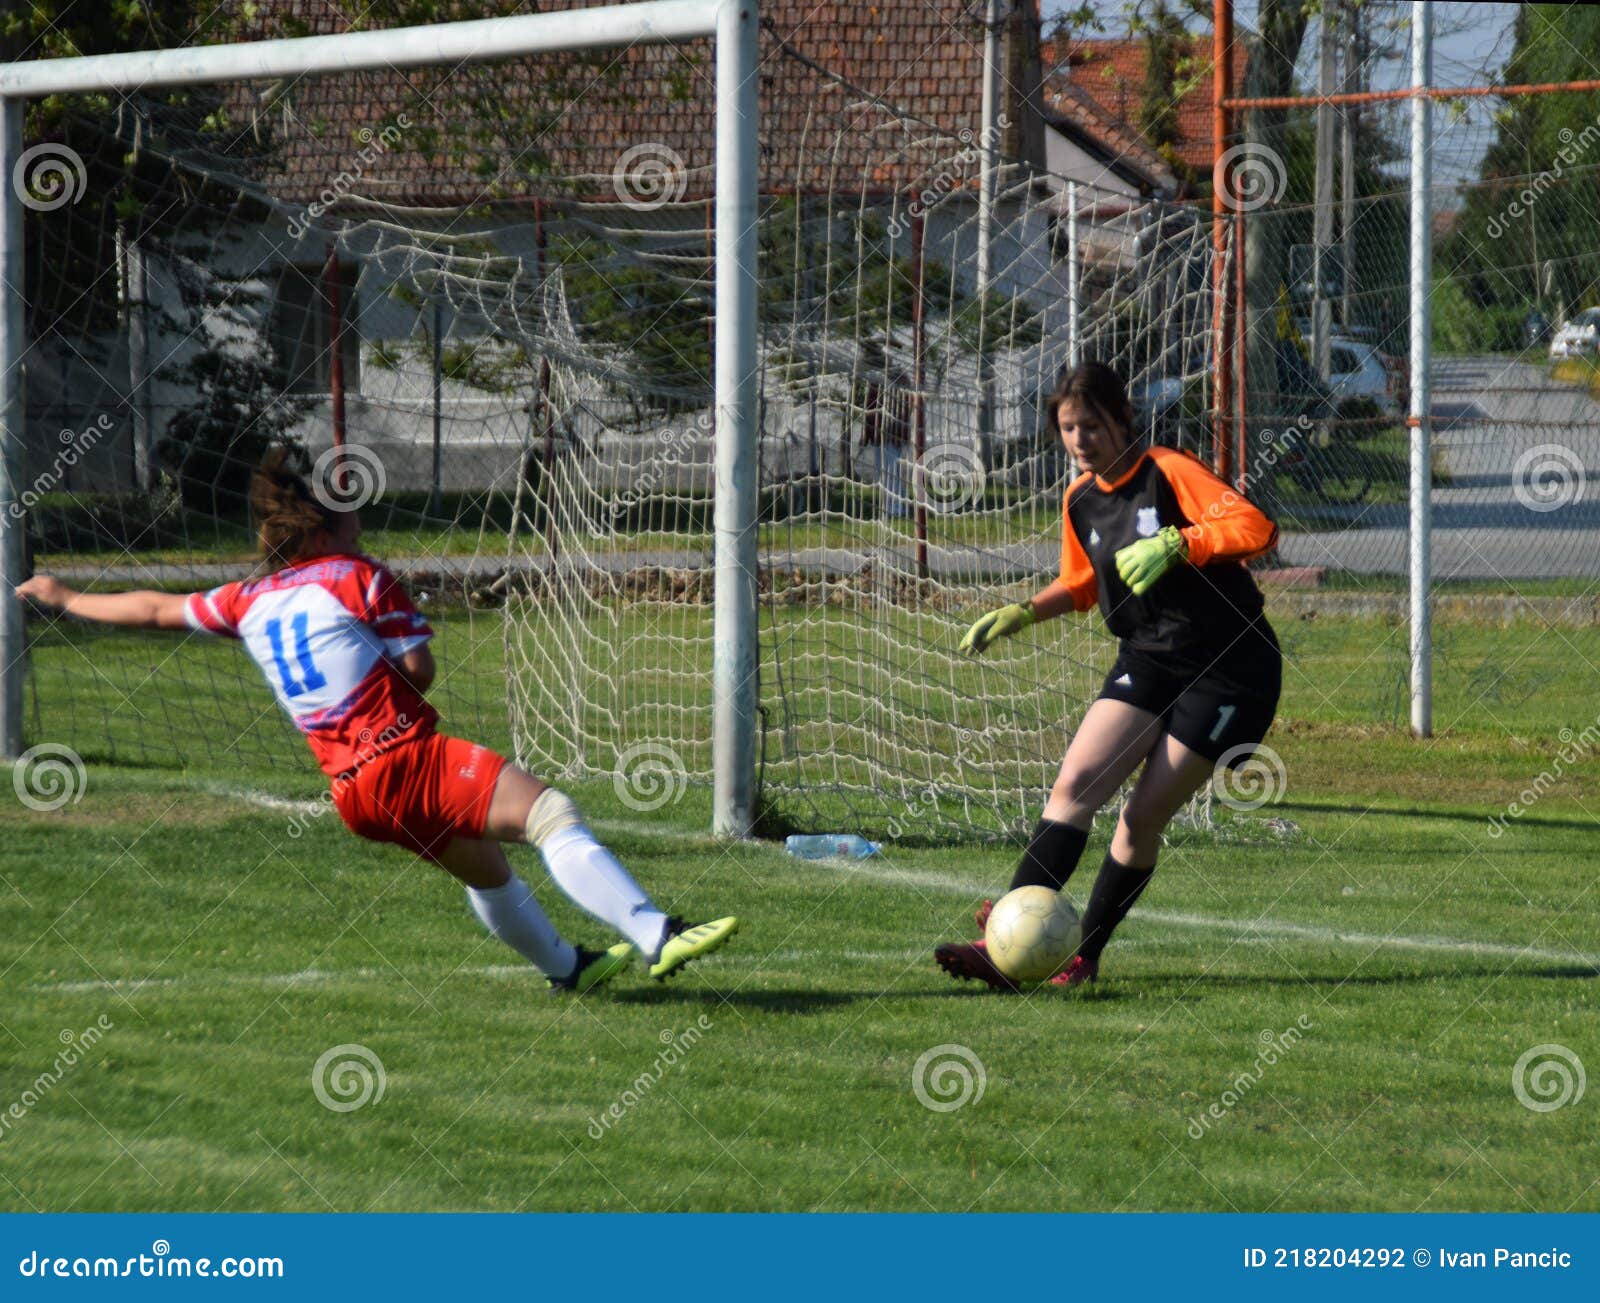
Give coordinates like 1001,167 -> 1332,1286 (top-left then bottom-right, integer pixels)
1406,0 -> 1434,738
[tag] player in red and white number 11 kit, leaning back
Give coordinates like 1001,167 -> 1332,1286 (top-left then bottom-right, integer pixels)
16,450 -> 739,992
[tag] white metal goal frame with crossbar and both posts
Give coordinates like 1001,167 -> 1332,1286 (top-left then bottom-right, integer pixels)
0,0 -> 758,837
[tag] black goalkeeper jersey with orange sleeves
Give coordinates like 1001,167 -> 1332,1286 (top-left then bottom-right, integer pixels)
1061,447 -> 1278,684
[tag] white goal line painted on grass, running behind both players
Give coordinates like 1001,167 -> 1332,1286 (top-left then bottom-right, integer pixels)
193,786 -> 1600,968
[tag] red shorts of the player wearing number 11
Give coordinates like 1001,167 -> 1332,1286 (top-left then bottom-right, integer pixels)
333,733 -> 506,860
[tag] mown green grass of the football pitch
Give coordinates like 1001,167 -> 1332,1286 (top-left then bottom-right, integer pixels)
0,601 -> 1600,1212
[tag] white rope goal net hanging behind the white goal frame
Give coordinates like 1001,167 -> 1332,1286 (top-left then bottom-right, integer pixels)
6,7 -> 1213,839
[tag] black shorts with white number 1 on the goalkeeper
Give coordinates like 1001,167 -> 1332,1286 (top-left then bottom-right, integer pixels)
1101,648 -> 1283,768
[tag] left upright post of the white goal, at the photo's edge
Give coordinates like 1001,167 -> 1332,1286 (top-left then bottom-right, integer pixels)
0,96 -> 27,759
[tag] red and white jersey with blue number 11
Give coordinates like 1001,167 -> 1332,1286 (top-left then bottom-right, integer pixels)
184,555 -> 438,778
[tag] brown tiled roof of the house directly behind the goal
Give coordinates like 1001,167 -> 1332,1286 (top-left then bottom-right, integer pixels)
222,0 -> 1075,205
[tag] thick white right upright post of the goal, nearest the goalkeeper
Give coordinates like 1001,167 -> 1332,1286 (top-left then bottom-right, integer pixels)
716,0 -> 760,837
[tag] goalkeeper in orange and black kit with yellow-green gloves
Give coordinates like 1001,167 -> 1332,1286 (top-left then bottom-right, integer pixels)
934,362 -> 1283,989
